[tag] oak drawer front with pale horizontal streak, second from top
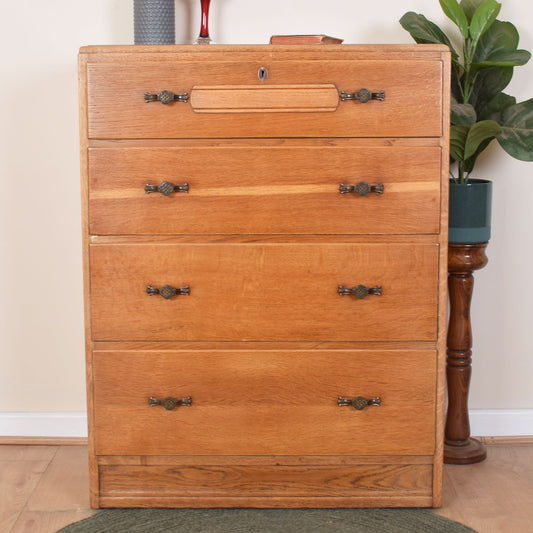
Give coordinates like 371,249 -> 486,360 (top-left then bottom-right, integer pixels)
89,145 -> 441,235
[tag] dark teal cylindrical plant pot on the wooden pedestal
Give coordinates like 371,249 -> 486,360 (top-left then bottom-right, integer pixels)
448,179 -> 492,244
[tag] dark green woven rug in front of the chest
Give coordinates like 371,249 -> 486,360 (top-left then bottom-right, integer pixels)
58,509 -> 475,533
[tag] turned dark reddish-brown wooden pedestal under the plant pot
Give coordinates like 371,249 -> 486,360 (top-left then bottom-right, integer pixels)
444,242 -> 488,464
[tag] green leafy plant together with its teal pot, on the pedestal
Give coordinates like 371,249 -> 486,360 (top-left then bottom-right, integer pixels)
400,0 -> 533,244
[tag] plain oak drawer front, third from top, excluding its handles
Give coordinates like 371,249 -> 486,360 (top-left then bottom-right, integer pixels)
90,243 -> 438,341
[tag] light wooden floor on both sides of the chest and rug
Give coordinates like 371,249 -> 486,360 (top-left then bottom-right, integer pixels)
0,444 -> 533,533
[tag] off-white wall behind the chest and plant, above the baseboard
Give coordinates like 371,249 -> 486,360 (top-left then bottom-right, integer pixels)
0,0 -> 533,434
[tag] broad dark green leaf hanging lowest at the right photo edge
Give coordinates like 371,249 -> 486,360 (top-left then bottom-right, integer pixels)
496,98 -> 533,161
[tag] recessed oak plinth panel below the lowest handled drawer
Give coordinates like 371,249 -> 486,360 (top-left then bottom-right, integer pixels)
99,458 -> 434,507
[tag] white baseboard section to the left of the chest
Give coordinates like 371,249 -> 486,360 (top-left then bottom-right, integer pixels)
0,413 -> 87,437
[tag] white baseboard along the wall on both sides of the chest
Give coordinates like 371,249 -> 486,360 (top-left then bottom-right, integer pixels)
0,409 -> 533,437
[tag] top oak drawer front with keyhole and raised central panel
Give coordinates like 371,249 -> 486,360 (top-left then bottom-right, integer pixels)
87,59 -> 443,139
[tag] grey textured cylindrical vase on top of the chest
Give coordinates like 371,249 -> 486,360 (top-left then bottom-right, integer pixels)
133,0 -> 176,44
